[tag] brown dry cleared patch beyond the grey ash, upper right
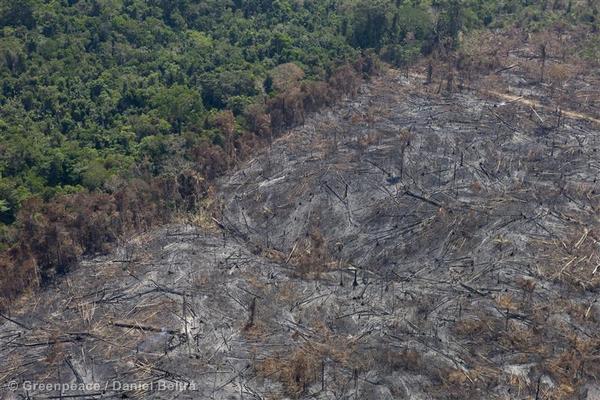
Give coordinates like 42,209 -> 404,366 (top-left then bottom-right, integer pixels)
418,15 -> 600,125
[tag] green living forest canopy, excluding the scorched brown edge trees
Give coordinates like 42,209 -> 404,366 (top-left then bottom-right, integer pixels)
0,0 -> 597,236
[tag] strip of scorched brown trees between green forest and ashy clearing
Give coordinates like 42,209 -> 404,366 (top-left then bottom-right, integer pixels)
0,58 -> 376,309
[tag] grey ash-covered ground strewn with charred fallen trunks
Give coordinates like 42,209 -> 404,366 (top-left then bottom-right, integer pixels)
0,71 -> 600,400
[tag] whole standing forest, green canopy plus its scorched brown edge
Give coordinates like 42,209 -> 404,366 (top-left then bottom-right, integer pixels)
0,0 -> 600,304
